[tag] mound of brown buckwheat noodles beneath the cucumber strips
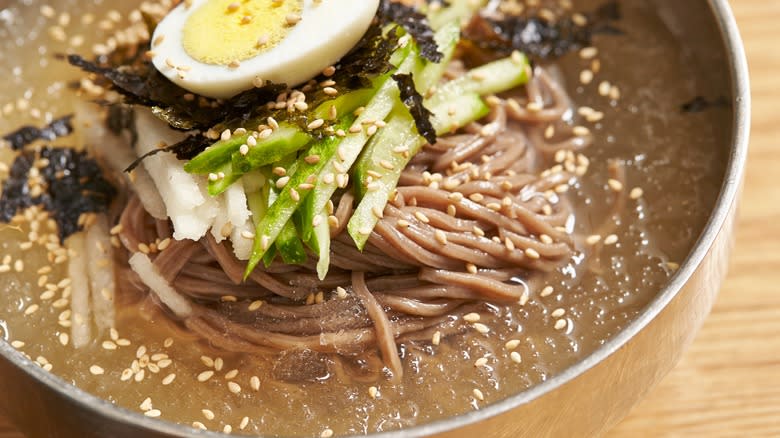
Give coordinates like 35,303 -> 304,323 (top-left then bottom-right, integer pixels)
114,64 -> 591,379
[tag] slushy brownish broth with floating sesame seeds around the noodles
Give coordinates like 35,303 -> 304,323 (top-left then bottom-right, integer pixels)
0,0 -> 729,436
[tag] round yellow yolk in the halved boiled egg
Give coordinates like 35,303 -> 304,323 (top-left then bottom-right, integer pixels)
182,0 -> 303,65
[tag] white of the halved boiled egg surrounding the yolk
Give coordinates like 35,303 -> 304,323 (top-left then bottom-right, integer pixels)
152,0 -> 379,98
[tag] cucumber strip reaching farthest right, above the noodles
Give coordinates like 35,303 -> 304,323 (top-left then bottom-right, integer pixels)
427,52 -> 531,107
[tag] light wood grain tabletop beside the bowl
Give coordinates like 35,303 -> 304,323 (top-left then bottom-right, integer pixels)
0,0 -> 780,438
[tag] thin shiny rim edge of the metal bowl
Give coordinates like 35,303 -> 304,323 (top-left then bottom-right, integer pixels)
0,0 -> 751,438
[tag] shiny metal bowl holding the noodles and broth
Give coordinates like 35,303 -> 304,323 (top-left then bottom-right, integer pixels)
0,0 -> 750,438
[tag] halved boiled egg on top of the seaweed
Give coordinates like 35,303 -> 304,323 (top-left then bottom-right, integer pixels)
149,0 -> 379,98
